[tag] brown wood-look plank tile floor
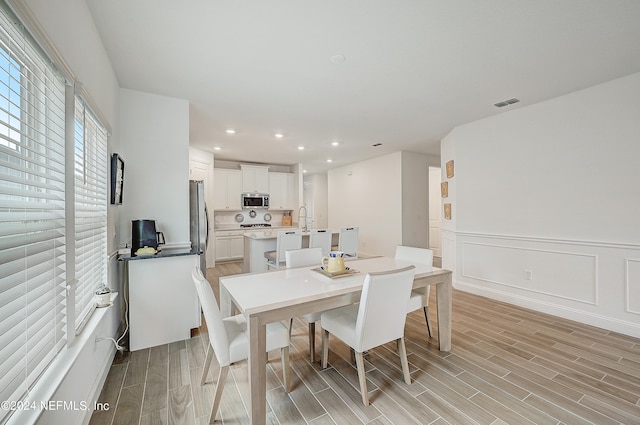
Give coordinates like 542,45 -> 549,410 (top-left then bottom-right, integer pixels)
90,263 -> 640,425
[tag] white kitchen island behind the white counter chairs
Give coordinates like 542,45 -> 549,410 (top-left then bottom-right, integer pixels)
242,229 -> 340,273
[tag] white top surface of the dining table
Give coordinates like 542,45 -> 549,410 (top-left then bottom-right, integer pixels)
220,257 -> 440,314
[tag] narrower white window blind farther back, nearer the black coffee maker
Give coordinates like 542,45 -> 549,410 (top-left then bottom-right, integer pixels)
74,96 -> 108,332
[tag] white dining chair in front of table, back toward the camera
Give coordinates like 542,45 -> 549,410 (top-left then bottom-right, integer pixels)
320,266 -> 415,406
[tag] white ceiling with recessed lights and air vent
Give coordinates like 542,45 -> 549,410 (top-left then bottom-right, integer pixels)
87,0 -> 640,173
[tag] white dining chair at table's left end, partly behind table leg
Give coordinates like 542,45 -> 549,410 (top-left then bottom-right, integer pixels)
191,267 -> 290,423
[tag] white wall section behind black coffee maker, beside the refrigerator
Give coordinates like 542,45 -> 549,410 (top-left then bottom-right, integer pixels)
119,89 -> 191,246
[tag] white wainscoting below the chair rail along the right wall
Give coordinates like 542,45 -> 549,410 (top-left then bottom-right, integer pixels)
450,231 -> 640,337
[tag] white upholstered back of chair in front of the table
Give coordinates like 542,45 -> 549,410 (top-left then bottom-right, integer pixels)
353,266 -> 415,352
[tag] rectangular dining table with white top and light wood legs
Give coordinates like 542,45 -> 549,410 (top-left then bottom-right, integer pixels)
220,257 -> 452,425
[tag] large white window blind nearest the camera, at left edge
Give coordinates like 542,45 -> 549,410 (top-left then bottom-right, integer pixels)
0,8 -> 67,422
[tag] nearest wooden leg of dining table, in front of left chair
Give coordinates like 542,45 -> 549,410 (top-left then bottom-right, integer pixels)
248,316 -> 267,425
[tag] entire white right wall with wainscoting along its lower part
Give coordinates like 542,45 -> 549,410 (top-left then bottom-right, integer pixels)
442,74 -> 640,336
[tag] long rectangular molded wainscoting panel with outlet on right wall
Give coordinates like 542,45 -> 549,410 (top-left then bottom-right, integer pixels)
462,241 -> 598,304
